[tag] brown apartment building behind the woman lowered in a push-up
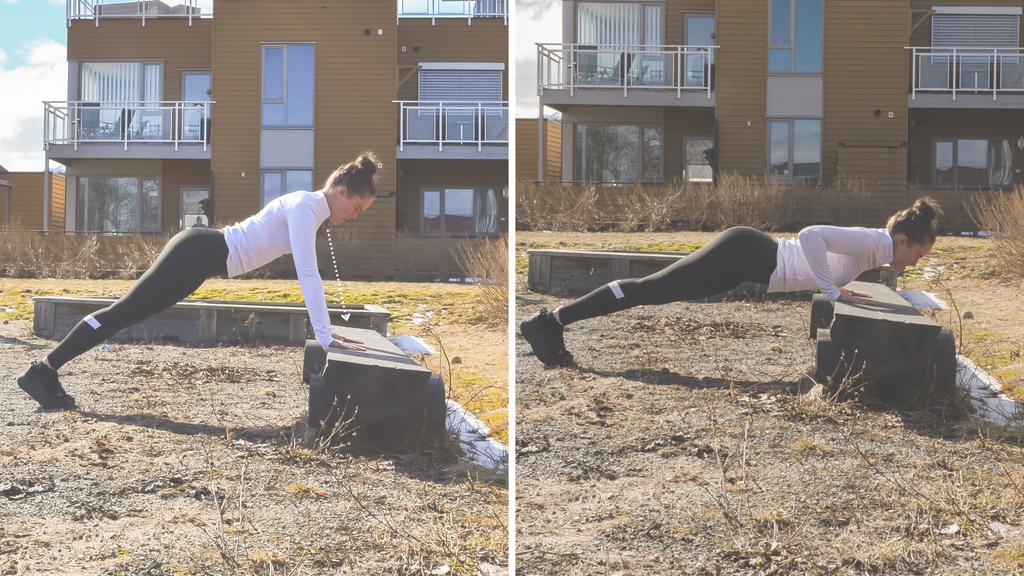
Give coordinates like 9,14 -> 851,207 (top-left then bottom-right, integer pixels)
530,0 -> 1024,224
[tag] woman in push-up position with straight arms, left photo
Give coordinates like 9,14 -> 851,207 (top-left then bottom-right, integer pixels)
17,152 -> 377,409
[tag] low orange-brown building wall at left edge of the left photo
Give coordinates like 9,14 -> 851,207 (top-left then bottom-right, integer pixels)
0,172 -> 65,231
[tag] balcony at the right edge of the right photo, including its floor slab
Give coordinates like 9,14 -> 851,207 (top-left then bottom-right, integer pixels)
906,46 -> 1024,109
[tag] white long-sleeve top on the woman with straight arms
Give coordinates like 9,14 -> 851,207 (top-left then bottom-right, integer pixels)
223,191 -> 334,347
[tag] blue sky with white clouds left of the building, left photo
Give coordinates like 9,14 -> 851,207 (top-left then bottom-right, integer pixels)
0,0 -> 68,172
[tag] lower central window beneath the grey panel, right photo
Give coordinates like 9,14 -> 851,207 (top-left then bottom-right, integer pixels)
767,120 -> 821,186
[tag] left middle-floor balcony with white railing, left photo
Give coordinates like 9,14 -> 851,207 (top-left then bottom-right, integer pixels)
43,100 -> 214,159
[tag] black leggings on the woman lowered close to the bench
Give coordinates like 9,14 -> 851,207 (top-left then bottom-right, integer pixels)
558,227 -> 778,325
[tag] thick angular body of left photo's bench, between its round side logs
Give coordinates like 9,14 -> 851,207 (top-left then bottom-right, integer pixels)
324,326 -> 431,422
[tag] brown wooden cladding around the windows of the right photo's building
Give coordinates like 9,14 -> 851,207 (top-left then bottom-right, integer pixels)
536,0 -> 1024,225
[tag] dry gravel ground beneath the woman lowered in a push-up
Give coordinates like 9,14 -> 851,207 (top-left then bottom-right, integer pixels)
515,291 -> 1024,576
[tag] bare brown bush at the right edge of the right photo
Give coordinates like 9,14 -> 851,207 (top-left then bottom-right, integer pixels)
971,184 -> 1024,277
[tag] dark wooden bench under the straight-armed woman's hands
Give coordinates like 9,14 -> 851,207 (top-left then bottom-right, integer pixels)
302,326 -> 445,440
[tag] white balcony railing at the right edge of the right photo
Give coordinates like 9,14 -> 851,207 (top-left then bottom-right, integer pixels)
906,46 -> 1024,100
